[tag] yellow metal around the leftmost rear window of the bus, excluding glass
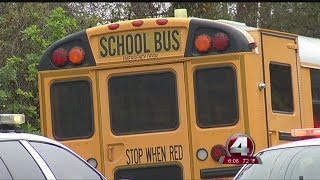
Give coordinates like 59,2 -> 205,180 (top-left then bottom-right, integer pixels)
39,69 -> 104,171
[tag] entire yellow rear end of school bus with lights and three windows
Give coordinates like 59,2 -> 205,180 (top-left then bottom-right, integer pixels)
39,18 -> 255,179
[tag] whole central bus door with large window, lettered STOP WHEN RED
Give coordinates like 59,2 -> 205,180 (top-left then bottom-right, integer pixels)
98,63 -> 192,179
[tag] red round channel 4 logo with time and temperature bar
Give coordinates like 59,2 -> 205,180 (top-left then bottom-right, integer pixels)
219,133 -> 262,164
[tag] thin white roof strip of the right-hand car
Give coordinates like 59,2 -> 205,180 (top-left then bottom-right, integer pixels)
260,138 -> 320,152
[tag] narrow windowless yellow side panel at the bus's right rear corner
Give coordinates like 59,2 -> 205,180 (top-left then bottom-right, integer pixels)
241,53 -> 268,152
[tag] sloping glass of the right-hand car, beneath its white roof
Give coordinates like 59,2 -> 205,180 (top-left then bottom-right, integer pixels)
235,146 -> 320,179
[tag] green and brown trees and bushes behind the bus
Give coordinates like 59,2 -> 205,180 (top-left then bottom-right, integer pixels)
0,2 -> 320,133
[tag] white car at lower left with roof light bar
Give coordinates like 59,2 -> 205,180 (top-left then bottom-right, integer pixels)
0,116 -> 105,180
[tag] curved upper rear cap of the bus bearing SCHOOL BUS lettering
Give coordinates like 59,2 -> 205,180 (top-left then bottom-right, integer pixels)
39,18 -> 256,71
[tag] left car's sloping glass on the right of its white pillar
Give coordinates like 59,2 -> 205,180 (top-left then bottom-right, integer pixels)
30,142 -> 101,179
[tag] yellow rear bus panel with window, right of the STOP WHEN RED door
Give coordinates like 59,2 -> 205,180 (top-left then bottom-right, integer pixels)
187,55 -> 246,179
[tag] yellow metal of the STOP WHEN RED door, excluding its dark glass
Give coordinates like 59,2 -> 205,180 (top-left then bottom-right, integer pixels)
98,63 -> 193,179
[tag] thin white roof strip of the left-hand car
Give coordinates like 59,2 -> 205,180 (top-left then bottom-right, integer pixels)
0,132 -> 65,147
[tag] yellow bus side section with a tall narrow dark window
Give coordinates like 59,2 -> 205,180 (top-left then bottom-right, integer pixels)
262,33 -> 301,146
